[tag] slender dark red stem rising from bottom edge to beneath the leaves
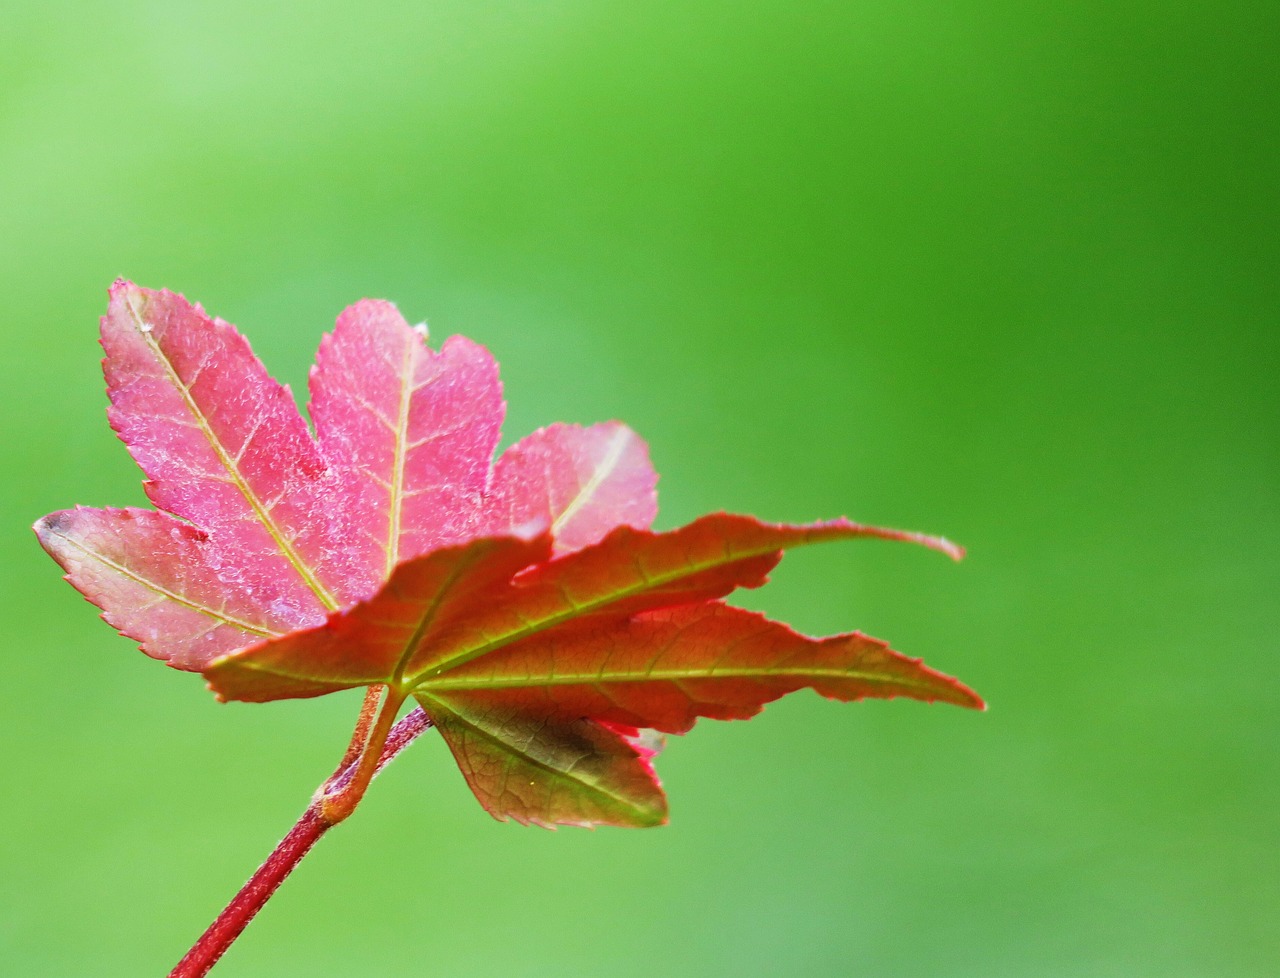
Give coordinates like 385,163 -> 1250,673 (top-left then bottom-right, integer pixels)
169,708 -> 431,978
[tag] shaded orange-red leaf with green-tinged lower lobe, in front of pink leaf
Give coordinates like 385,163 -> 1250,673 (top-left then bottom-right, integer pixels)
205,513 -> 982,826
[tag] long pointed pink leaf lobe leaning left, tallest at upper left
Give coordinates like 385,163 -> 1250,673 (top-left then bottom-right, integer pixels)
102,282 -> 349,609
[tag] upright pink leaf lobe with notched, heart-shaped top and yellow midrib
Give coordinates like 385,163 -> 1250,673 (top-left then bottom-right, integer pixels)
311,300 -> 506,593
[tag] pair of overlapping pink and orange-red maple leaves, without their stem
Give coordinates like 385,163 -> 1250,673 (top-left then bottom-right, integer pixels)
36,282 -> 983,826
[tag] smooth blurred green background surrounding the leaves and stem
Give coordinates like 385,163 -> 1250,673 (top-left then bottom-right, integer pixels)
0,0 -> 1280,978
